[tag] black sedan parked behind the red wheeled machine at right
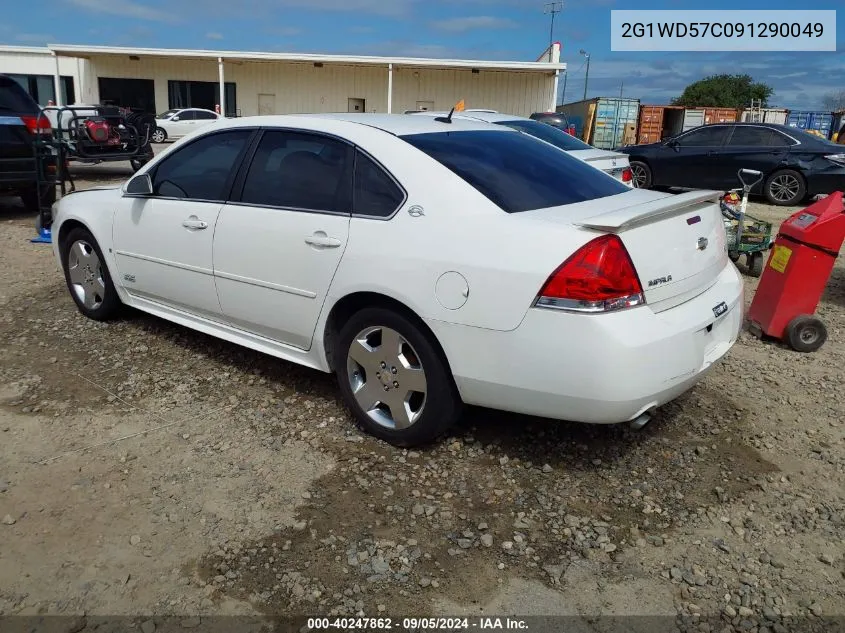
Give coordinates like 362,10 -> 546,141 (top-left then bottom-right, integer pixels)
618,123 -> 845,206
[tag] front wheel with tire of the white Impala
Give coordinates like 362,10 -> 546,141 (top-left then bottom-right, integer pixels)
61,227 -> 123,321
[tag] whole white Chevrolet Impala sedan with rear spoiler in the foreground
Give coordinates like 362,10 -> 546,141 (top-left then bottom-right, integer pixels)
53,114 -> 743,446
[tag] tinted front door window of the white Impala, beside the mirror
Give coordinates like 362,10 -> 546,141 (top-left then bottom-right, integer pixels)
153,130 -> 252,200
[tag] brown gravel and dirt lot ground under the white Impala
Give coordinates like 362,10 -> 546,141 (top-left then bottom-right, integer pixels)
0,159 -> 845,633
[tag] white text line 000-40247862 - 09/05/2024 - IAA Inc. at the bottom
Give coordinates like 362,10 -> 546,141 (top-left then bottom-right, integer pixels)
306,617 -> 528,631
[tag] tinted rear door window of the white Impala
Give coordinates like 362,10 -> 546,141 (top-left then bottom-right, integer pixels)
241,130 -> 352,213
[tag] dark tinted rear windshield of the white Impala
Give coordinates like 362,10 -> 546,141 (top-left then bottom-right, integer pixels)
402,130 -> 630,213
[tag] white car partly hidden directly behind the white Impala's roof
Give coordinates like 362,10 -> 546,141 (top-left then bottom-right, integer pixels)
412,110 -> 634,187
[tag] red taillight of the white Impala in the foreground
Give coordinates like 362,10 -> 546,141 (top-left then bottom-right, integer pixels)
535,235 -> 645,312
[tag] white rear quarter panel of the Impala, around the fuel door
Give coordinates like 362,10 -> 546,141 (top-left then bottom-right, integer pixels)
327,123 -> 593,330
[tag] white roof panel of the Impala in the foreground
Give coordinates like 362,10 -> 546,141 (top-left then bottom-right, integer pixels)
218,112 -> 506,136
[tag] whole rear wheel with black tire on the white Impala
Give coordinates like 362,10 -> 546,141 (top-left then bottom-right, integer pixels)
336,308 -> 462,447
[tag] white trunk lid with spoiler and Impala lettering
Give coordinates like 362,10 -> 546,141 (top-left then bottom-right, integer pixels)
526,189 -> 728,312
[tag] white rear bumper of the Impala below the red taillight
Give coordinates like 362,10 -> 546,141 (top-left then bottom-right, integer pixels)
429,264 -> 744,423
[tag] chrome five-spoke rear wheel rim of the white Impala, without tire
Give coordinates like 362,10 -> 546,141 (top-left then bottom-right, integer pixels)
346,326 -> 426,430
